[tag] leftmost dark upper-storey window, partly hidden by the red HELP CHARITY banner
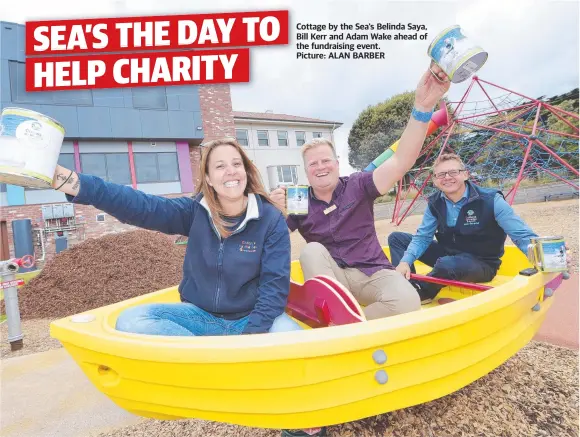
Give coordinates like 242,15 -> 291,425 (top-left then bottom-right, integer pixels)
8,61 -> 93,106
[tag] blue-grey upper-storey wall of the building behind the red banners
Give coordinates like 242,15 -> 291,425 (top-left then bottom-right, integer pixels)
0,22 -> 203,141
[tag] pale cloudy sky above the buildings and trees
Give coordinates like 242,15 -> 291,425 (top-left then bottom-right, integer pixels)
0,0 -> 580,175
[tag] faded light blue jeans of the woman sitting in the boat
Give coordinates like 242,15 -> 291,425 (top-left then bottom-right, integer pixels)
115,302 -> 302,336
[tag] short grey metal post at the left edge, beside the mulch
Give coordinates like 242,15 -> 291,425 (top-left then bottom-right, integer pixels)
0,260 -> 24,351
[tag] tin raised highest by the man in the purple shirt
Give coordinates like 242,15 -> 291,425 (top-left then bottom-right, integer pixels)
427,26 -> 488,83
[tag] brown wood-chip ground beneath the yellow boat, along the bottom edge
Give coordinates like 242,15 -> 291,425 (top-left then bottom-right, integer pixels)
88,342 -> 578,437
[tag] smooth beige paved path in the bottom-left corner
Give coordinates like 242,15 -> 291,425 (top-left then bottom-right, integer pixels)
0,348 -> 141,437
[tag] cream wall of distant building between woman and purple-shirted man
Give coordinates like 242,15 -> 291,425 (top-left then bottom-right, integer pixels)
236,120 -> 333,190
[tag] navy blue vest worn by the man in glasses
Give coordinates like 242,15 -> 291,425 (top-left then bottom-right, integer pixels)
428,181 -> 507,268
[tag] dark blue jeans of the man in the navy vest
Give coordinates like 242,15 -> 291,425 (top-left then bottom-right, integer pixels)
388,232 -> 497,298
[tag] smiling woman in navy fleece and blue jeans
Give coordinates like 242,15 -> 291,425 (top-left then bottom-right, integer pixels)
53,138 -> 301,336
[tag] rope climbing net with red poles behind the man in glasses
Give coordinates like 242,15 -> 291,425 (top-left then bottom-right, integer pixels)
392,76 -> 580,225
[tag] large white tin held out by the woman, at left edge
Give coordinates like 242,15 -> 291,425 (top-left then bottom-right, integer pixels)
0,108 -> 65,188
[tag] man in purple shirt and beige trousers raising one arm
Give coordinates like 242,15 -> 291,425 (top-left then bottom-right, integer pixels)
270,65 -> 449,320
